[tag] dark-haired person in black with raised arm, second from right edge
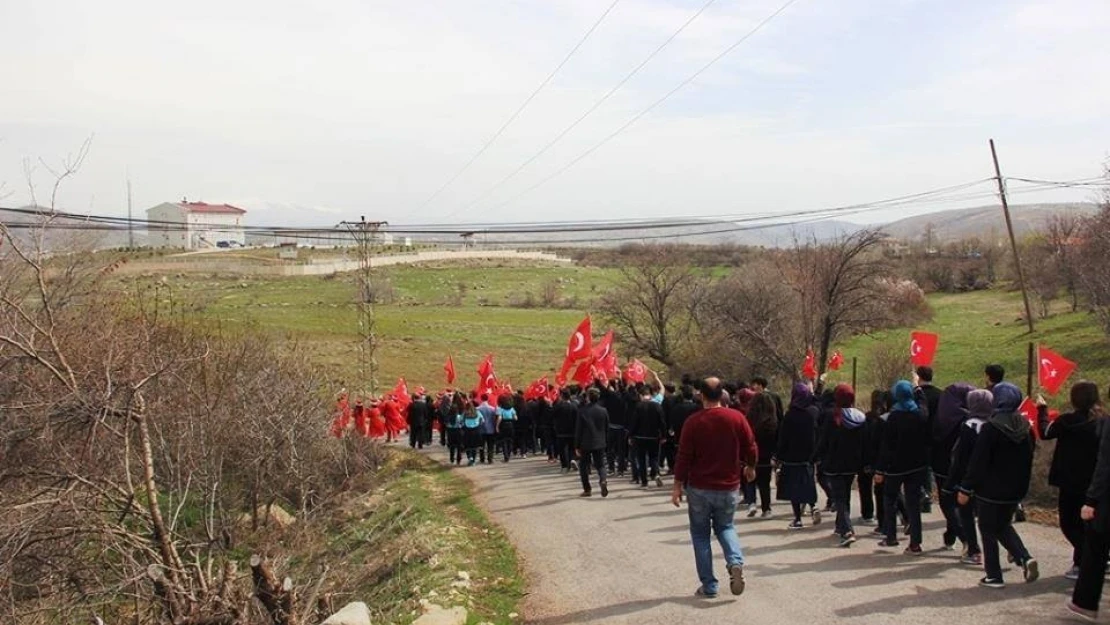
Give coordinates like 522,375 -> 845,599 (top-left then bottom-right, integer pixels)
1037,380 -> 1102,579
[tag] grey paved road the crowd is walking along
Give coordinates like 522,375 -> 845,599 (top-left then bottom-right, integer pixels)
431,447 -> 1092,625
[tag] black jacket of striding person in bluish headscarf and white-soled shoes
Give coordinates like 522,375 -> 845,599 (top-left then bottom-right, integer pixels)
959,414 -> 1035,504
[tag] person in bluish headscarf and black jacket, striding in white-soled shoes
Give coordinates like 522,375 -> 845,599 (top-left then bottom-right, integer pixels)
958,382 -> 1040,588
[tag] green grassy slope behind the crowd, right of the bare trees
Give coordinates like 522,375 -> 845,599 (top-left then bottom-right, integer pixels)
829,291 -> 1110,400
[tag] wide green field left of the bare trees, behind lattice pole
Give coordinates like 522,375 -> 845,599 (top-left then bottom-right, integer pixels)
130,263 -> 616,389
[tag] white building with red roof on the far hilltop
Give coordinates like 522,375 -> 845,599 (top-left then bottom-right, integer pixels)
147,200 -> 246,250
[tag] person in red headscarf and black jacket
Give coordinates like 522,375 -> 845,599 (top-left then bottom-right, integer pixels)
816,384 -> 867,547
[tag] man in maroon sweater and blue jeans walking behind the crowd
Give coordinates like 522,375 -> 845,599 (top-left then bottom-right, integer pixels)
670,377 -> 759,598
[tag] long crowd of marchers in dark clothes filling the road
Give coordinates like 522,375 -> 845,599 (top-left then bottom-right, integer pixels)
333,365 -> 1110,619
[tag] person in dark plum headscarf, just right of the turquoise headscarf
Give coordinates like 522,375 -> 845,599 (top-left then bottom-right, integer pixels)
926,382 -> 975,550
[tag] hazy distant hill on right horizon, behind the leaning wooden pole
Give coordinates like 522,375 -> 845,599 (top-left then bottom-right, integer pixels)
878,202 -> 1098,243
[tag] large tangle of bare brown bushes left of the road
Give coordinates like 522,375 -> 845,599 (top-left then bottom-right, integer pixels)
0,219 -> 361,625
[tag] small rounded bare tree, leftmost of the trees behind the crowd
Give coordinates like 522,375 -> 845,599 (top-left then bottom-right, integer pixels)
598,245 -> 703,366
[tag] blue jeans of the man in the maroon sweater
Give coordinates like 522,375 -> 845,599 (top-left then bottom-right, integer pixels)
686,486 -> 744,595
